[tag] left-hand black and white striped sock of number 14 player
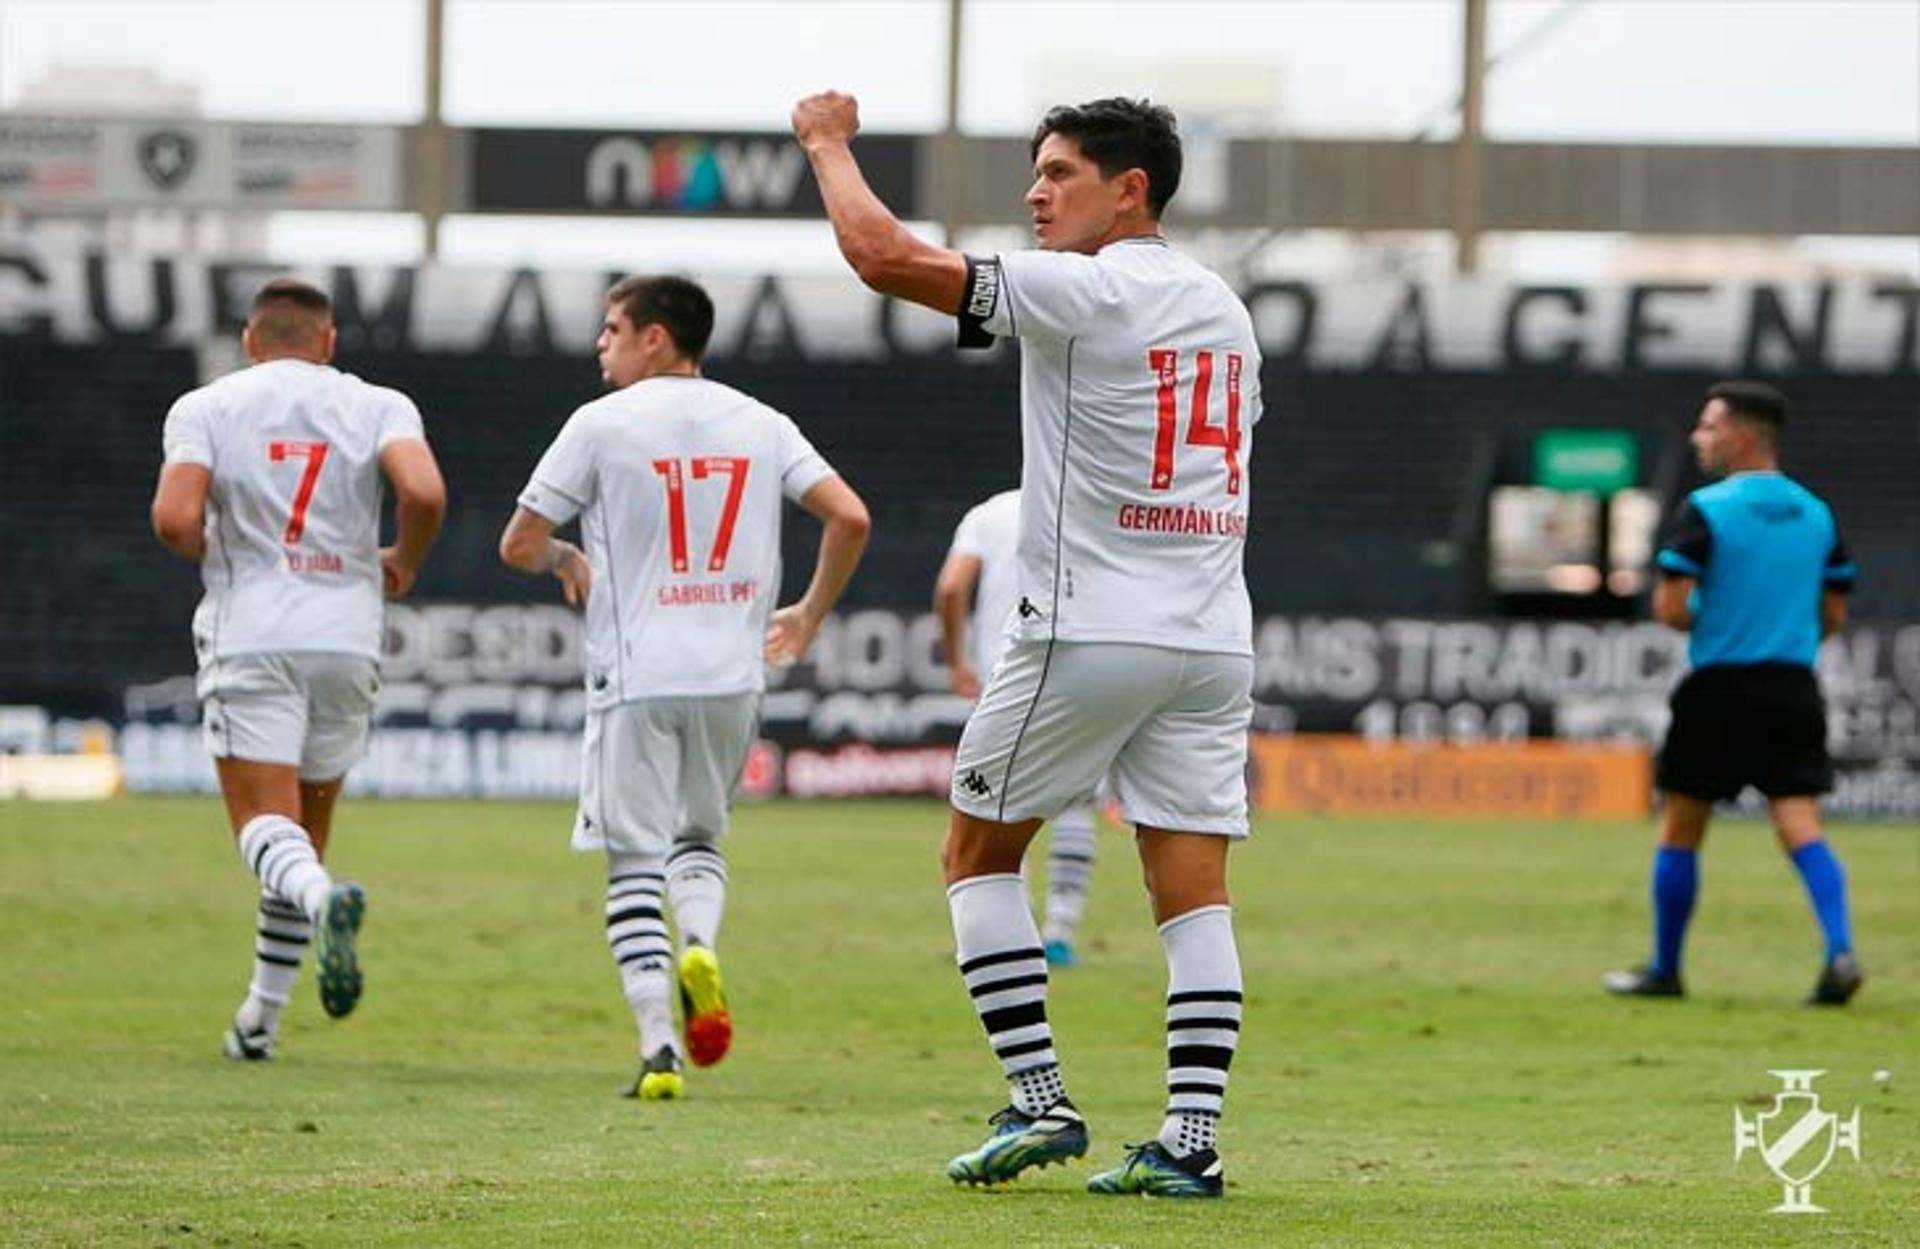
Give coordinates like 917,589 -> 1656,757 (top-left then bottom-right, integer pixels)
947,873 -> 1066,1115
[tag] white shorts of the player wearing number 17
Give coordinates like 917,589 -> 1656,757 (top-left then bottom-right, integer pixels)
574,695 -> 760,858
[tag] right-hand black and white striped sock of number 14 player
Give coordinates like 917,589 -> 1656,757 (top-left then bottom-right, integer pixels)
1160,906 -> 1242,1157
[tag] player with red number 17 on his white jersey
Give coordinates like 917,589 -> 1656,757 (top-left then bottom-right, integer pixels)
499,276 -> 868,1099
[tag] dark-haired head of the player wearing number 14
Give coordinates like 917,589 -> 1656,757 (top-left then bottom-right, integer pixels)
1027,98 -> 1181,251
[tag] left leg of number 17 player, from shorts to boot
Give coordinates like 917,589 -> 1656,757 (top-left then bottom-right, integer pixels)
572,702 -> 682,1099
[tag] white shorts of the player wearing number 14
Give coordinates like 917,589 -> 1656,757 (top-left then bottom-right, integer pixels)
952,641 -> 1254,837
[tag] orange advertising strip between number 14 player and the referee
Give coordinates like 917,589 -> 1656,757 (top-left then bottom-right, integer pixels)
1252,733 -> 1653,819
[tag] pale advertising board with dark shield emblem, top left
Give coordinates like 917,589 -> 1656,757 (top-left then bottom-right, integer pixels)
0,117 -> 403,211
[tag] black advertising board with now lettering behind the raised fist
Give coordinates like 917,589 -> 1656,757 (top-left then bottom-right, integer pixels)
470,130 -> 920,217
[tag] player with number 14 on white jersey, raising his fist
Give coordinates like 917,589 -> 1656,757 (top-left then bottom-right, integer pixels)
793,92 -> 1260,1197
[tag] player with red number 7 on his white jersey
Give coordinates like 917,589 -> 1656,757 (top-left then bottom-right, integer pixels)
154,278 -> 447,1061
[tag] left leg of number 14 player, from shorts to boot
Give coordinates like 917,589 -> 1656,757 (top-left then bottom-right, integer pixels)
943,643 -> 1136,1184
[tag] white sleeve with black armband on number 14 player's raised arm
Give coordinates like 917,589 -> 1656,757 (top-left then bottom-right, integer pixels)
960,251 -> 1119,345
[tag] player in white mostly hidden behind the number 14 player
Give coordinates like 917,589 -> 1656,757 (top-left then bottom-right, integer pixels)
933,489 -> 1098,967
